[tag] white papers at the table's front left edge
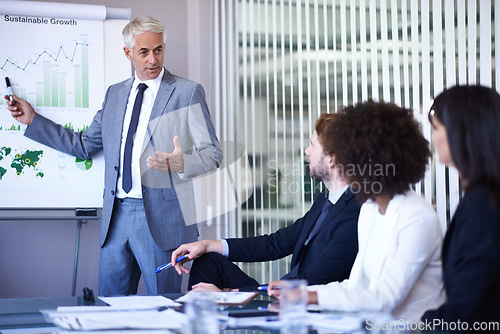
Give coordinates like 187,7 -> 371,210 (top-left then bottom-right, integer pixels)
40,307 -> 187,331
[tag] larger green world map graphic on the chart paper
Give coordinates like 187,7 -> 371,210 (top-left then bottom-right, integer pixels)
0,147 -> 45,180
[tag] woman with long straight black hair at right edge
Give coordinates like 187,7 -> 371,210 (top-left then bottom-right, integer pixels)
423,86 -> 500,324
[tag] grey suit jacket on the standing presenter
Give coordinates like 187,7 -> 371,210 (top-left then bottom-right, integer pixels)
25,71 -> 222,250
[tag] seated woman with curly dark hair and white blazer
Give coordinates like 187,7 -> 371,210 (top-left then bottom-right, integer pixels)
268,101 -> 444,321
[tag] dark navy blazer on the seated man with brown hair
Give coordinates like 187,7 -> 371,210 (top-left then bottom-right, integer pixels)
227,189 -> 360,284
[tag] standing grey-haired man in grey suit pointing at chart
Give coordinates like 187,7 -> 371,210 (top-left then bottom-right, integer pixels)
8,17 -> 222,296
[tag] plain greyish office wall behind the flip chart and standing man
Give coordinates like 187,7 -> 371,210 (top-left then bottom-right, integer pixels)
0,0 -> 214,298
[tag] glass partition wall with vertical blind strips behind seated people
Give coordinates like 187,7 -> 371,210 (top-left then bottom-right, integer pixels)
208,0 -> 500,282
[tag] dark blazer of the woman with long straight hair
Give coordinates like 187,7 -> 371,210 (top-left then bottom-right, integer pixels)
422,188 -> 500,324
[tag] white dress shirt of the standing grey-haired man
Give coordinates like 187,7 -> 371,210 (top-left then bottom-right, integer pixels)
116,68 -> 165,198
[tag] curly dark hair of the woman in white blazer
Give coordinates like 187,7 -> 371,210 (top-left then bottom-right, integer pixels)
324,100 -> 431,203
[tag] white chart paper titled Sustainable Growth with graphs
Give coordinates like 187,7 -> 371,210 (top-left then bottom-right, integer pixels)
0,12 -> 105,208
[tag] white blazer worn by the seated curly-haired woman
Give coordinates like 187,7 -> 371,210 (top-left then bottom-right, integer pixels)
309,191 -> 445,321
